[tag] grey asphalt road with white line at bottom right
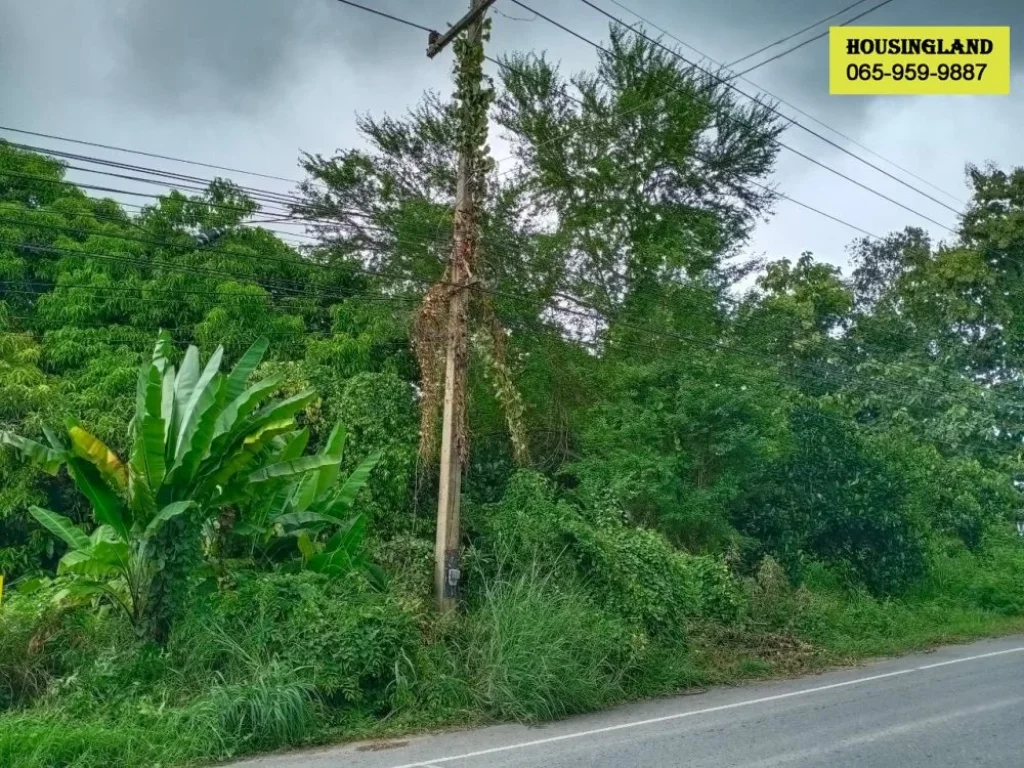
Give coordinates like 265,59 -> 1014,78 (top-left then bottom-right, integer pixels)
238,637 -> 1024,768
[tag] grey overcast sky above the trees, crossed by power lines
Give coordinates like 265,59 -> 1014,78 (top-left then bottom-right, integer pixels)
0,0 -> 1024,274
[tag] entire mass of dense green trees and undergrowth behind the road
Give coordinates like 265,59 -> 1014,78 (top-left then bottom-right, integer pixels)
0,31 -> 1024,768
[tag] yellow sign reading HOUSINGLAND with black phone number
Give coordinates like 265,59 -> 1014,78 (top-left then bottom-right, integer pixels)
828,27 -> 1010,96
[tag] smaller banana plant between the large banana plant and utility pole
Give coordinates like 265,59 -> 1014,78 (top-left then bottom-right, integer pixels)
236,424 -> 384,587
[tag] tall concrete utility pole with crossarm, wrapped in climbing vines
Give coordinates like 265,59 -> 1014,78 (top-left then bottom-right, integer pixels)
419,0 -> 496,611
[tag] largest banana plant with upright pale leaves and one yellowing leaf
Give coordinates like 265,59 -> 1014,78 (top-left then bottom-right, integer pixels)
0,332 -> 337,638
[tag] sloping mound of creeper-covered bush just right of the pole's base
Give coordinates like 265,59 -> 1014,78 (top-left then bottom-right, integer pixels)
468,472 -> 740,640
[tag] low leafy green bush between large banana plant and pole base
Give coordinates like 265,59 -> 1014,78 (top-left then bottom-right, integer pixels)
169,572 -> 418,709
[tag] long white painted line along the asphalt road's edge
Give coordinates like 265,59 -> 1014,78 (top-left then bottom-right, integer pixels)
392,646 -> 1024,768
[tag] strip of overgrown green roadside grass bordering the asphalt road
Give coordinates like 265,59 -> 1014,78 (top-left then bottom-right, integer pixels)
0,542 -> 1024,768
